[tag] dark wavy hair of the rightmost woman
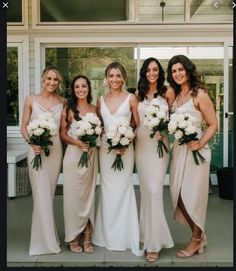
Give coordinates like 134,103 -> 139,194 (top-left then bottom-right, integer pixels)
167,55 -> 207,97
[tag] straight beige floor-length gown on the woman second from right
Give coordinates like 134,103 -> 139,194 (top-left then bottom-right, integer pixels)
135,96 -> 174,252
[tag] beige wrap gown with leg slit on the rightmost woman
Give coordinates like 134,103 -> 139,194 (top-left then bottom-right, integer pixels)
170,98 -> 211,238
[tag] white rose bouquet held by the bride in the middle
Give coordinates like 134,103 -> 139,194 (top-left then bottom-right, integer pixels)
106,117 -> 134,171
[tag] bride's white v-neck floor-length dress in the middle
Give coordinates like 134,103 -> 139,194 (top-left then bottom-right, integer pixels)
92,94 -> 143,256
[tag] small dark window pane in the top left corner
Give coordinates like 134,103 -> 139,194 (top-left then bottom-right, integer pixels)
7,0 -> 23,23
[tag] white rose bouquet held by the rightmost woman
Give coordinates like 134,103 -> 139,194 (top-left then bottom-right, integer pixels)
168,113 -> 206,165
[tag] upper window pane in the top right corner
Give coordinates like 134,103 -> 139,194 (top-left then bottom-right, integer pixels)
190,0 -> 233,22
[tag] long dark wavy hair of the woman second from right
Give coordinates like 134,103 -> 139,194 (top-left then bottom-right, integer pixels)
138,57 -> 167,101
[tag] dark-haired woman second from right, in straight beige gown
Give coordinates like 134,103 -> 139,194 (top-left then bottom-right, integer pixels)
135,57 -> 175,262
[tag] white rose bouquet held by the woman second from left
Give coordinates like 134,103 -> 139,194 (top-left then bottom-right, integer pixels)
75,113 -> 102,168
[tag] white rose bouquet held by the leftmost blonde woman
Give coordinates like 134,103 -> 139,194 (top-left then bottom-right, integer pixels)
27,113 -> 57,170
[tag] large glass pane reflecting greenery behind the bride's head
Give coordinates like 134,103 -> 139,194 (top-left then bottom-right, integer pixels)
46,47 -> 137,104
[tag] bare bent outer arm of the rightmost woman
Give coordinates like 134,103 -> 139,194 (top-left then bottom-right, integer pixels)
187,90 -> 218,150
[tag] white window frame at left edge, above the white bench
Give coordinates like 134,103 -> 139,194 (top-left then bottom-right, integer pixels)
7,35 -> 30,137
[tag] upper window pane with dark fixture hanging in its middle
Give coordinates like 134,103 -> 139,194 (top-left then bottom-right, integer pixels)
138,0 -> 184,22
